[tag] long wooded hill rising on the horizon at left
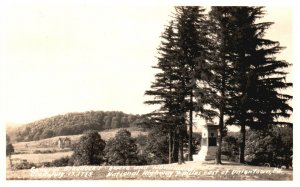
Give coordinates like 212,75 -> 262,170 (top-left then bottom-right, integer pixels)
7,111 -> 145,142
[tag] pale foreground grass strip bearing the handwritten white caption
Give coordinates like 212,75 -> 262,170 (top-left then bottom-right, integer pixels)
6,162 -> 293,180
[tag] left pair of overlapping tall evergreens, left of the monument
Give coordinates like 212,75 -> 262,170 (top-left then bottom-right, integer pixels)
145,7 -> 212,163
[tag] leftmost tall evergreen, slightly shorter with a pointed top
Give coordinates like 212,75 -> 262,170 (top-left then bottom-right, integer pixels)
145,21 -> 180,163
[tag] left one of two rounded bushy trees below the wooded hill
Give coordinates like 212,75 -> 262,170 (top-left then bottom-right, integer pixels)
72,131 -> 105,166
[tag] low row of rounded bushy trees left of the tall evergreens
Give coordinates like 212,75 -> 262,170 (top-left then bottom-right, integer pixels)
6,128 -> 188,170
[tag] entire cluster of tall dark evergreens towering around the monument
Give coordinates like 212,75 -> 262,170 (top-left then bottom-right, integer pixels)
145,6 -> 293,164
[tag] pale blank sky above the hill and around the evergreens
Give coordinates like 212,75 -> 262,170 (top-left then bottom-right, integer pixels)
1,1 -> 293,123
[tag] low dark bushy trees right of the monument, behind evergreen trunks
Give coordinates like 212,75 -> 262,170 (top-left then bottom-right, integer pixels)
222,126 -> 293,168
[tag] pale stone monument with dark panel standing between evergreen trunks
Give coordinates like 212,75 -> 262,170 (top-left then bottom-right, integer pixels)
193,124 -> 218,161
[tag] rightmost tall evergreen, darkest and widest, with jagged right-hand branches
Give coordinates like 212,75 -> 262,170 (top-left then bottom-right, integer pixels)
223,7 -> 292,163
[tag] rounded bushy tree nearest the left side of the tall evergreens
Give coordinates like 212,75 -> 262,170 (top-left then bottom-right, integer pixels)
104,129 -> 138,165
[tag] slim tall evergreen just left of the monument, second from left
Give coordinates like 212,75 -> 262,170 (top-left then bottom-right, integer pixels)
175,6 -> 209,160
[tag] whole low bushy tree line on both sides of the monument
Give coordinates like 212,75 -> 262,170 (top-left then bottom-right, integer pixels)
6,127 -> 293,169
